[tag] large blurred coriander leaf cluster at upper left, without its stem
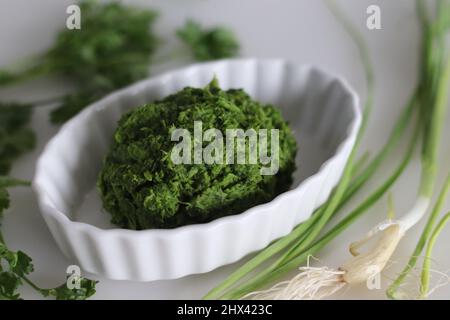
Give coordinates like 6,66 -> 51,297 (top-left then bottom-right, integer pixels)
44,1 -> 159,123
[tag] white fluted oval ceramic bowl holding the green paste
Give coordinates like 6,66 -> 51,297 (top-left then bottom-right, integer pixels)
33,59 -> 361,281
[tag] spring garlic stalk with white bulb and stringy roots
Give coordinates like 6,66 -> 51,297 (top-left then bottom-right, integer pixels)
234,0 -> 450,299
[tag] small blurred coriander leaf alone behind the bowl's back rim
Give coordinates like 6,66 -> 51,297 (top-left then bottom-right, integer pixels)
177,20 -> 239,61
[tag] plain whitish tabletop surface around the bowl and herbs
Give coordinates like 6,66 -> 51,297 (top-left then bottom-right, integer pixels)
0,0 -> 450,299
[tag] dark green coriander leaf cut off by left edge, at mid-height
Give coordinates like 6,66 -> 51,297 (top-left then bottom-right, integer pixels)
0,103 -> 36,174
